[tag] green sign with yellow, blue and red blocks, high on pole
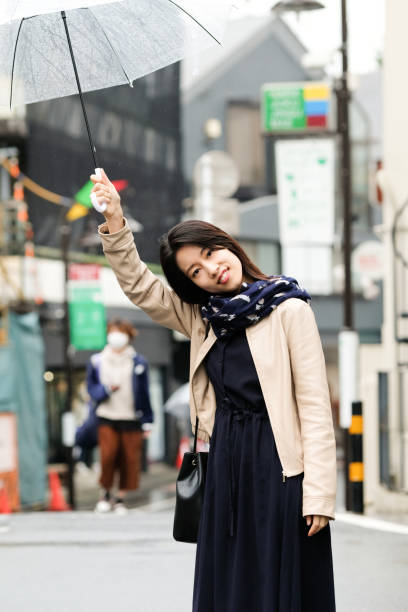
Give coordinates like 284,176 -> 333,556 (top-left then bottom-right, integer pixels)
262,81 -> 331,133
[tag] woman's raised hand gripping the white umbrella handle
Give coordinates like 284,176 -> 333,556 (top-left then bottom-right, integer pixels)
90,168 -> 123,234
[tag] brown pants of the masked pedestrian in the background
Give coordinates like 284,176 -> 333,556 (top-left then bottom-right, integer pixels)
98,424 -> 143,491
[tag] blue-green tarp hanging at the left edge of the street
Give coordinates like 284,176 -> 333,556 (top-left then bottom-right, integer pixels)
0,312 -> 47,506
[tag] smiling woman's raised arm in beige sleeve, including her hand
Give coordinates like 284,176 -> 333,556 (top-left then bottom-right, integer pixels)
91,170 -> 195,337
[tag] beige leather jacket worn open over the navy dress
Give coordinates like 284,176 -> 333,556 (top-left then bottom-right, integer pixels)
99,224 -> 336,518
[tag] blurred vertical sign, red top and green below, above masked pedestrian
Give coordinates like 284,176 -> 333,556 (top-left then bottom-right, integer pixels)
68,264 -> 106,351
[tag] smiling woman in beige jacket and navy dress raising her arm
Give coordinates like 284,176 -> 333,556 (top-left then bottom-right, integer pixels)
91,174 -> 336,612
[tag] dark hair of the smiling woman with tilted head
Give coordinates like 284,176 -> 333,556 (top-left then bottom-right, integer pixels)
160,219 -> 268,304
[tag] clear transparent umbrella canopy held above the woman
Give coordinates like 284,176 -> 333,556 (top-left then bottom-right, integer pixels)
0,0 -> 231,106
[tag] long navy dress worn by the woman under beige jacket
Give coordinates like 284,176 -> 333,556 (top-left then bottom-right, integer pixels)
193,331 -> 335,612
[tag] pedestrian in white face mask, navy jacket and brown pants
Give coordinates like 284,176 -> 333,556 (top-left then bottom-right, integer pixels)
87,319 -> 153,514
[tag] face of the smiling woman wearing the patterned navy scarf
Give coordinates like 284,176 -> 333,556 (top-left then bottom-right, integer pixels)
176,244 -> 244,293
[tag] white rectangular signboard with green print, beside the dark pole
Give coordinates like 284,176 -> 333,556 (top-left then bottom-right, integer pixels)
275,138 -> 335,246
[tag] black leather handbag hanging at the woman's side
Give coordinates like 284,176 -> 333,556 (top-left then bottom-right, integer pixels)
173,418 -> 208,544
